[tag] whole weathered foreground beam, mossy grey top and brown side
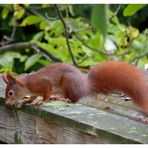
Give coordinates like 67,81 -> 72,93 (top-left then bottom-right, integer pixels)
0,100 -> 148,143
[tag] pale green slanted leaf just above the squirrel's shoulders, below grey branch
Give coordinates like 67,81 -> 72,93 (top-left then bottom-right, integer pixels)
25,53 -> 42,70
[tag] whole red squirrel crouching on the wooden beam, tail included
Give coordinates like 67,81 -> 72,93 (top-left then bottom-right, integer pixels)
2,61 -> 148,112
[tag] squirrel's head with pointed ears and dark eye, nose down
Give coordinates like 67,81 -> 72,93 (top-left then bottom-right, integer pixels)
2,73 -> 25,105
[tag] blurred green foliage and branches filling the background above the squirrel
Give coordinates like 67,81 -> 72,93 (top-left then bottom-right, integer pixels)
0,4 -> 148,74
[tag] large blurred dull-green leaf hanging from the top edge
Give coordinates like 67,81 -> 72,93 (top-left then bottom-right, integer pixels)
91,4 -> 107,39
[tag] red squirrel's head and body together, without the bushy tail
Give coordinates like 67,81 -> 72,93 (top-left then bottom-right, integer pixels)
3,63 -> 88,105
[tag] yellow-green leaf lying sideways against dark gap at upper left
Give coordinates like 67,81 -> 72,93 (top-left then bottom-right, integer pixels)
20,15 -> 44,26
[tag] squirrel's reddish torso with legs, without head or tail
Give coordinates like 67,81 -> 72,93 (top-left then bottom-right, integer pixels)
24,63 -> 86,102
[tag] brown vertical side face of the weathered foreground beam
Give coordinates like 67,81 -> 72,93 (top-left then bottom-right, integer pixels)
0,104 -> 109,144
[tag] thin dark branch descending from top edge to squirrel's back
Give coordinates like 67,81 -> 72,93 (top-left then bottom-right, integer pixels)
53,4 -> 77,66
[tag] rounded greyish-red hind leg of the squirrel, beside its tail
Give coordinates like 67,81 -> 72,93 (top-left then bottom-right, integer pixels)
61,73 -> 86,103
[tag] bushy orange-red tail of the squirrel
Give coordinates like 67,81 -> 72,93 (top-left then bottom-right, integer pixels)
88,61 -> 148,112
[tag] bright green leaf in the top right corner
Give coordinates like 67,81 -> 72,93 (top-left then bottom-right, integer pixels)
123,4 -> 146,16
